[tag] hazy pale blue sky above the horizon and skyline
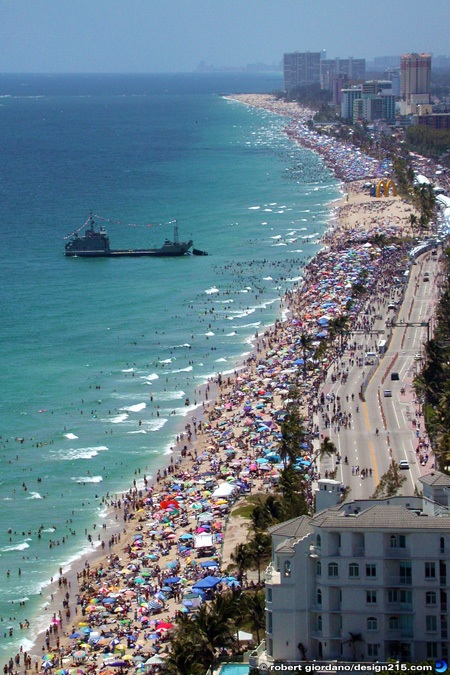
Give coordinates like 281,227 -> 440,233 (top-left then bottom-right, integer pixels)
0,0 -> 450,72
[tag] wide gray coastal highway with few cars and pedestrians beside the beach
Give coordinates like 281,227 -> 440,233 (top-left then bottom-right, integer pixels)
315,248 -> 441,499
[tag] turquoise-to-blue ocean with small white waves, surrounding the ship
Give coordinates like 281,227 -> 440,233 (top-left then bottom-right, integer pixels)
0,74 -> 340,661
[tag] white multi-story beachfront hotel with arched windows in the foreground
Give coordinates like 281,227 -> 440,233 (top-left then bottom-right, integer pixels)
251,472 -> 450,665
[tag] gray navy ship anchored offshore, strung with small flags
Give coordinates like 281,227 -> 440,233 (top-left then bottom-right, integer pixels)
64,214 -> 193,258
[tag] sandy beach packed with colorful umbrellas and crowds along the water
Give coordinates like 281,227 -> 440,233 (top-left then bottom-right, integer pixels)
5,95 -> 426,673
